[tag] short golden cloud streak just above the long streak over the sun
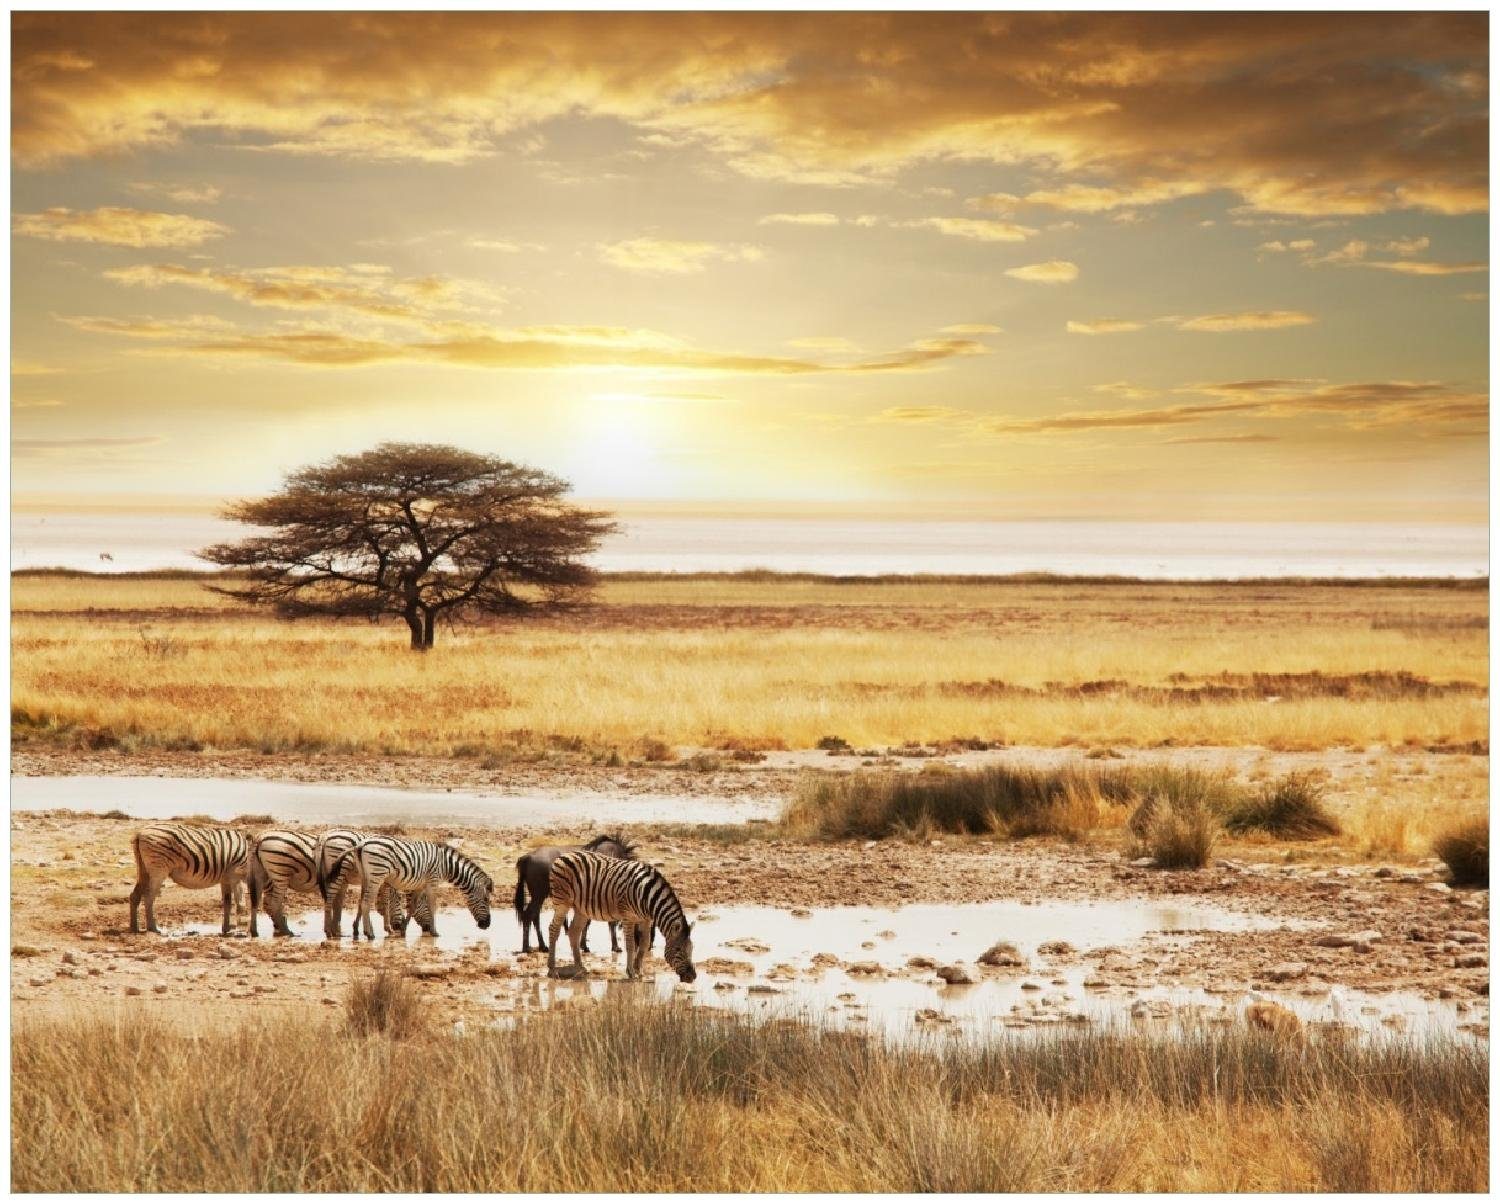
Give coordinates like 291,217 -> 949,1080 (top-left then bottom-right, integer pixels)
104,264 -> 498,322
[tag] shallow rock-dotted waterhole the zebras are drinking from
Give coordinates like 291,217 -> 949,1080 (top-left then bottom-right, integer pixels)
195,900 -> 1488,1039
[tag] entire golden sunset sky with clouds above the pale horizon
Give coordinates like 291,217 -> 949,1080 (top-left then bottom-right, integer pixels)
12,12 -> 1490,522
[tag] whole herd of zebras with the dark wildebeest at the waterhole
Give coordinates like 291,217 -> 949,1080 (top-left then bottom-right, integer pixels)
131,823 -> 698,982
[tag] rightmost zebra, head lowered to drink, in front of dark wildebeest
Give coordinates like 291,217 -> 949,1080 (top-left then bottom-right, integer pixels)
548,850 -> 698,982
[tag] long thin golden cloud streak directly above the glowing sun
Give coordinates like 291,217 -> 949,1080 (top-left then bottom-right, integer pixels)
63,315 -> 987,376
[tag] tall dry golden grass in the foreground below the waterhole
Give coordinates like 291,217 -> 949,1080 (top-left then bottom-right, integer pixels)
12,1002 -> 1488,1192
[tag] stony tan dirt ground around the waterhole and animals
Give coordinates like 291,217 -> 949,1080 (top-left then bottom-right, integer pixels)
11,750 -> 1490,1024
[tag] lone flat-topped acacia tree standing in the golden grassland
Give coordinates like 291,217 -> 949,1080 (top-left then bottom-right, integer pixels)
198,444 -> 615,651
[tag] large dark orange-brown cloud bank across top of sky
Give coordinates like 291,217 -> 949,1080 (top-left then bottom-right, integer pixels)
12,12 -> 1488,216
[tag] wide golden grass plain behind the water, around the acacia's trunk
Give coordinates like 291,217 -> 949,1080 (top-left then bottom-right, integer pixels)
12,576 -> 1488,756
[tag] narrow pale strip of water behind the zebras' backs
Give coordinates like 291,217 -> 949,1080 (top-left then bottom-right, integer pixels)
11,777 -> 780,828
